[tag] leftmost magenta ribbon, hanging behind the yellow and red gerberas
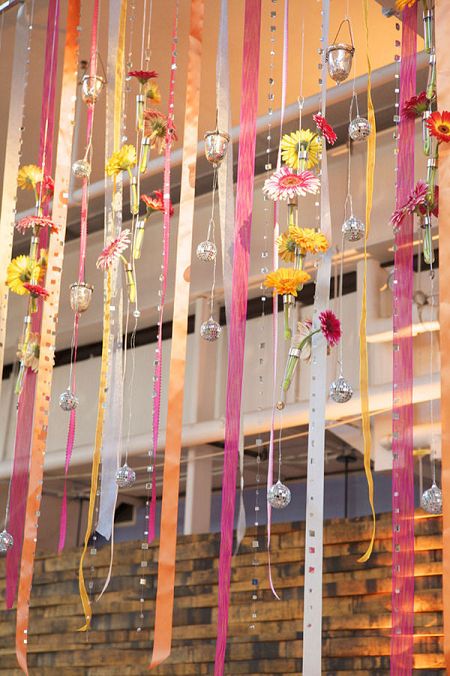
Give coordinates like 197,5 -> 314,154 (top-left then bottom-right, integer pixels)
6,0 -> 60,608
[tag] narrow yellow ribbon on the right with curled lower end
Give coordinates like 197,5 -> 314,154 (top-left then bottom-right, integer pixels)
358,0 -> 377,563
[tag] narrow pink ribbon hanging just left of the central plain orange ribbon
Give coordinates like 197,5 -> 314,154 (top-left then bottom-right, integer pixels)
147,0 -> 179,543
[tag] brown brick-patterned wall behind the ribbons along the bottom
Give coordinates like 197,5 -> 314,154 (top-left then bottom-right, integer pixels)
0,515 -> 445,676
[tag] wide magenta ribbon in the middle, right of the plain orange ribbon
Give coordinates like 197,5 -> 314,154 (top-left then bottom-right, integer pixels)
214,0 -> 261,676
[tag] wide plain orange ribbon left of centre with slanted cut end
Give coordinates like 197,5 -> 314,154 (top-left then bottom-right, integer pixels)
150,0 -> 205,668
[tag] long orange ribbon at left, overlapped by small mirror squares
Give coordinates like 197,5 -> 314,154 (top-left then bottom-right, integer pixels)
16,0 -> 80,674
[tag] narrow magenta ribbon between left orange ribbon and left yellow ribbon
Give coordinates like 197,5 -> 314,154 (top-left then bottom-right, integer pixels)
58,0 -> 99,552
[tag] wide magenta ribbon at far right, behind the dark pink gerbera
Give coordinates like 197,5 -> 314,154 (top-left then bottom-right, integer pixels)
391,5 -> 417,676
